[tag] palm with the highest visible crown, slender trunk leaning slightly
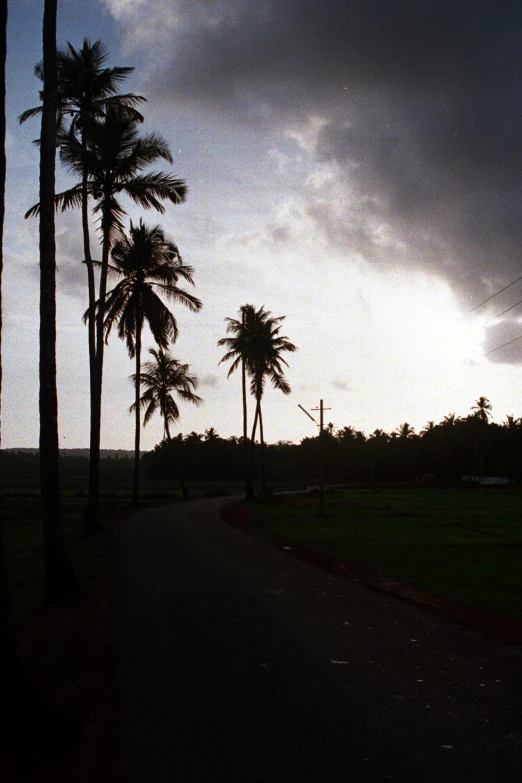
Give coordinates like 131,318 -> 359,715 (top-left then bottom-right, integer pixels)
20,39 -> 145,532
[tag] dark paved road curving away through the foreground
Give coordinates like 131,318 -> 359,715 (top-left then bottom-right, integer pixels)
117,499 -> 522,783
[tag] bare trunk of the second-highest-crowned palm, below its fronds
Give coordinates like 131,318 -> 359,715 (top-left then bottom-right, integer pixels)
85,193 -> 111,532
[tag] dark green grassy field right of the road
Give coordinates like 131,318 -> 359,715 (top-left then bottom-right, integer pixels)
248,488 -> 522,616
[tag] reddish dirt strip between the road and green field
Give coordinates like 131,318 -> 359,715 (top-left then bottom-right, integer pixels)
221,503 -> 522,647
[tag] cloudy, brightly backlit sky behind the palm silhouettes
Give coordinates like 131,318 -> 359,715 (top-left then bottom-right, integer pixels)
2,0 -> 522,449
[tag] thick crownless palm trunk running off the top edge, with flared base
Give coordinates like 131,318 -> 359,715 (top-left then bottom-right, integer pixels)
40,0 -> 75,603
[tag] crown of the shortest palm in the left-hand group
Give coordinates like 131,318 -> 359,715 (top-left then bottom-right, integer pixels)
130,348 -> 201,441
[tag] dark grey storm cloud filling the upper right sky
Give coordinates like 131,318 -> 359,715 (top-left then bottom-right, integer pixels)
149,0 -> 522,305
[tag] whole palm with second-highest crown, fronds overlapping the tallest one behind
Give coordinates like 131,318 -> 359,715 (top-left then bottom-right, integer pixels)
26,105 -> 187,529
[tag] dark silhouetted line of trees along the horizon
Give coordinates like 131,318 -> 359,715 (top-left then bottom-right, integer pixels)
142,397 -> 522,486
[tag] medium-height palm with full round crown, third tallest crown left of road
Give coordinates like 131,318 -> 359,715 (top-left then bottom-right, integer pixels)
97,220 -> 201,505
